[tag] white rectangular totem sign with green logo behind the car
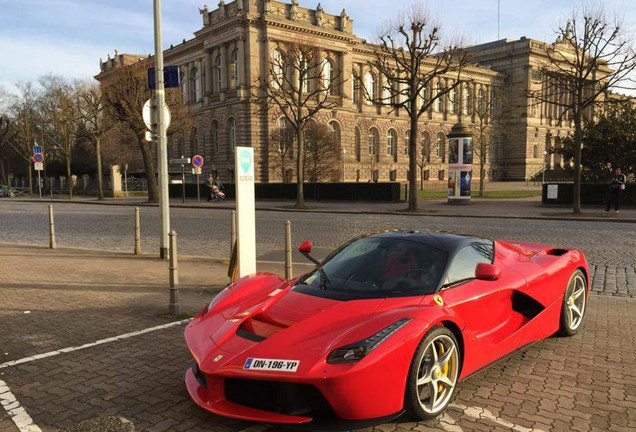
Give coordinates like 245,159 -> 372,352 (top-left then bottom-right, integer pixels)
234,147 -> 256,277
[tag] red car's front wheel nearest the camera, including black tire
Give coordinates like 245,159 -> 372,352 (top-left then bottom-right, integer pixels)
404,326 -> 461,420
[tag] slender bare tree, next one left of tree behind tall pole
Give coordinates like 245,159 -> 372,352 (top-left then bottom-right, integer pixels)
78,81 -> 112,200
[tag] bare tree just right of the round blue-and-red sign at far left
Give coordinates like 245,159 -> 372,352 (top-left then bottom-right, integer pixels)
40,75 -> 80,198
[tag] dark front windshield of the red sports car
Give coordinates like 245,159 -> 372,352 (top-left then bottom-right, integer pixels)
299,237 -> 447,298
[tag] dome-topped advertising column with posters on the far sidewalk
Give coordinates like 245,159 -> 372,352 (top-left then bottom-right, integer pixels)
448,123 -> 473,204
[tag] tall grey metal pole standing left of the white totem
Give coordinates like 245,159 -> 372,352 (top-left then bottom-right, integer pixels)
154,0 -> 170,259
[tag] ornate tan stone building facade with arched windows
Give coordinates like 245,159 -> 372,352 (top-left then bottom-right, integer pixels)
96,0 -> 596,182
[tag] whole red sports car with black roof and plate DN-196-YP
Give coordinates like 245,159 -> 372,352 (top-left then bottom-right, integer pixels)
185,230 -> 589,429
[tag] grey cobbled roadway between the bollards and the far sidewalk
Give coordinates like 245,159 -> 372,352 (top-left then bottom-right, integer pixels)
0,201 -> 636,297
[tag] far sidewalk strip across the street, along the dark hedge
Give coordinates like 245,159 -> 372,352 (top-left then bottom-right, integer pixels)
6,197 -> 636,223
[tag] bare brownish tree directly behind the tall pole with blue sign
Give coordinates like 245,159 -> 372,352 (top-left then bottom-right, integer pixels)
102,61 -> 188,202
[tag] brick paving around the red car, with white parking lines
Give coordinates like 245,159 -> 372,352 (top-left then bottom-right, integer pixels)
0,246 -> 636,432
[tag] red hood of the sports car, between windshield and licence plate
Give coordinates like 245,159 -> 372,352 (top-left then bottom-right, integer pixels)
186,280 -> 432,371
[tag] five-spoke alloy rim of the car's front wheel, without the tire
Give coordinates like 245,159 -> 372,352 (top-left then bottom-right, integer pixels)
417,335 -> 459,414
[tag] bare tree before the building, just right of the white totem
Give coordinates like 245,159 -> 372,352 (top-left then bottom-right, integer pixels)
252,42 -> 343,207
